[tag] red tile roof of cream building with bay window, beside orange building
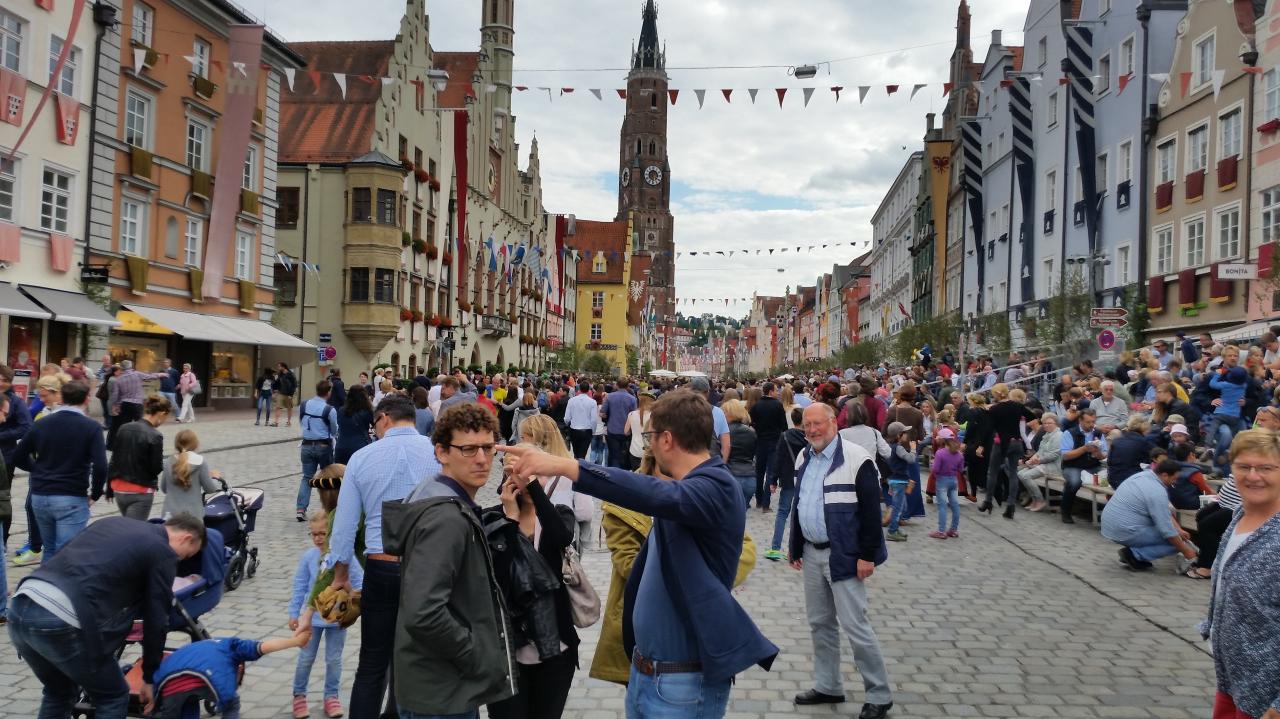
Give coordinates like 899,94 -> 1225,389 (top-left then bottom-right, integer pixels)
280,40 -> 396,162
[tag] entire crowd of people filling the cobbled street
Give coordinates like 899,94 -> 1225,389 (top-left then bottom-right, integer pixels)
0,328 -> 1280,719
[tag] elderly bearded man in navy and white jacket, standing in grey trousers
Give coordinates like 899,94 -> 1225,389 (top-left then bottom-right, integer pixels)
790,403 -> 893,719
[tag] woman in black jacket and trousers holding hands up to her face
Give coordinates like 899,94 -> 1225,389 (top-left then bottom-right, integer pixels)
484,444 -> 579,719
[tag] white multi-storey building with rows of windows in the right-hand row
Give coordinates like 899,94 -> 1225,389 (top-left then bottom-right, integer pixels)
865,151 -> 924,339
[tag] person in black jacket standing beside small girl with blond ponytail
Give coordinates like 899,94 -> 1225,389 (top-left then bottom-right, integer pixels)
106,394 -> 173,514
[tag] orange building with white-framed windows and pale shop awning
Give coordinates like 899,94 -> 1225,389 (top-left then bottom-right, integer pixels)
88,0 -> 307,407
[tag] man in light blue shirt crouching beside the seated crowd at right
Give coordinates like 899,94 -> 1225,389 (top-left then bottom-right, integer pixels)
1102,458 -> 1199,573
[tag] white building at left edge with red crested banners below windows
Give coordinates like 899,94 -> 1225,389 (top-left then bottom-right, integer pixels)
0,3 -> 118,386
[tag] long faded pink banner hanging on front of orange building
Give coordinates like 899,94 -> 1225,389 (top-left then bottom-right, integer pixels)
201,24 -> 262,302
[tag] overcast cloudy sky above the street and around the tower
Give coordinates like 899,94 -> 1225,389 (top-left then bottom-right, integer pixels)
262,0 -> 1025,316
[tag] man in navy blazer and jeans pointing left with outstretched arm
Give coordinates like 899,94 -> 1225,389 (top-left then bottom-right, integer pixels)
500,390 -> 778,718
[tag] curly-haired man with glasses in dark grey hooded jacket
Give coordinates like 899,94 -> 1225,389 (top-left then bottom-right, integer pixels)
384,400 -> 517,719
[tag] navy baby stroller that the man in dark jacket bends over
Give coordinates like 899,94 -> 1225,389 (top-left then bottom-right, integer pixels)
72,528 -> 227,719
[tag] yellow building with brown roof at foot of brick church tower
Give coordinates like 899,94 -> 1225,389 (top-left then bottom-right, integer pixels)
564,219 -> 635,370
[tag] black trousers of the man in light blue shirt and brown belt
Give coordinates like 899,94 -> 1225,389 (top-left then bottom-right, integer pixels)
347,559 -> 401,719
